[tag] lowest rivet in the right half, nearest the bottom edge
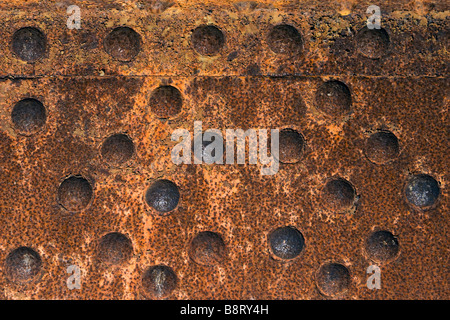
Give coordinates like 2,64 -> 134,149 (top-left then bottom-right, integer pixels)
316,263 -> 350,296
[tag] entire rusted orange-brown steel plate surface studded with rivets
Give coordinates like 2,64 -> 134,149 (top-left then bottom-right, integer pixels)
0,1 -> 450,299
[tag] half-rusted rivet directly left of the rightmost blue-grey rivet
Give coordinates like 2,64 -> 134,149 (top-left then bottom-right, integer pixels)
321,178 -> 356,213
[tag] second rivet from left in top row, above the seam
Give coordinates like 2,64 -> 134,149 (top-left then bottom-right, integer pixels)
104,27 -> 141,62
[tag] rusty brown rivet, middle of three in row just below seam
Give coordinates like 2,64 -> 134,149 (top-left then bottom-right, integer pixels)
149,86 -> 183,119
